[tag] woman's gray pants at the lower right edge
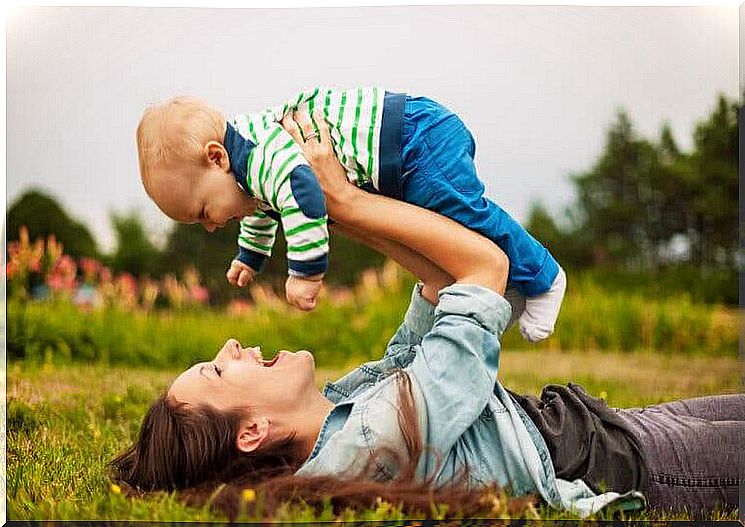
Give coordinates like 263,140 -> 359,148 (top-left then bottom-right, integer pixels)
618,394 -> 745,513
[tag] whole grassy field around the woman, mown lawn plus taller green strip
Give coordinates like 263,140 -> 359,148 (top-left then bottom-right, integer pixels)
7,265 -> 740,521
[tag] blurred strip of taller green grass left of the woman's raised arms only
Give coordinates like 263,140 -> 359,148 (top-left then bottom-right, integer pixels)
7,280 -> 408,367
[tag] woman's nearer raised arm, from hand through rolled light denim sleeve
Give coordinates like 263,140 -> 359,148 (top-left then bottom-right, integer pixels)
288,111 -> 511,462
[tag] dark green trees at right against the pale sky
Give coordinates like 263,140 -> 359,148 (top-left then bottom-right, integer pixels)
528,95 -> 739,272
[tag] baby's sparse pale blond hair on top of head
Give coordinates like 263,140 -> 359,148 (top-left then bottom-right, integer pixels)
137,96 -> 225,194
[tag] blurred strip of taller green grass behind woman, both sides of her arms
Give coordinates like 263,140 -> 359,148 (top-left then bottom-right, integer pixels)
7,274 -> 738,374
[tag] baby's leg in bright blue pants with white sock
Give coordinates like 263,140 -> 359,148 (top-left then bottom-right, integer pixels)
401,103 -> 566,341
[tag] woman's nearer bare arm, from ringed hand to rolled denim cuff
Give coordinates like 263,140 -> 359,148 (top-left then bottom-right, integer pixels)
282,113 -> 509,294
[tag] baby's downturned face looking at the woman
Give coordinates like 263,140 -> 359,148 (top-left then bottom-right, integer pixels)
150,164 -> 258,232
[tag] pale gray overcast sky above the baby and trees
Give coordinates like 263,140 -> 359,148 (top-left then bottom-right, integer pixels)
7,6 -> 738,249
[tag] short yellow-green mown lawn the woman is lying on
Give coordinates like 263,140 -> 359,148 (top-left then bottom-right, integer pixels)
7,349 -> 739,521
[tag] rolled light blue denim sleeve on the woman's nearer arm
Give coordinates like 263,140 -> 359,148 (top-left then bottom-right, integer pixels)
407,284 -> 512,460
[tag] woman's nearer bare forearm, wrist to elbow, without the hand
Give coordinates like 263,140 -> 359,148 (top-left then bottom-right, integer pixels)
325,185 -> 509,294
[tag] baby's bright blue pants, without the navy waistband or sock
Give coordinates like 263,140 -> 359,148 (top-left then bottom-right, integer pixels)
401,96 -> 559,296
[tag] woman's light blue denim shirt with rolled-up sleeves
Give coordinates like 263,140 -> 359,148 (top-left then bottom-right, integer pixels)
297,284 -> 644,517
